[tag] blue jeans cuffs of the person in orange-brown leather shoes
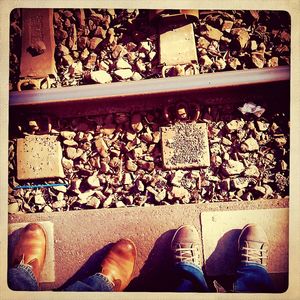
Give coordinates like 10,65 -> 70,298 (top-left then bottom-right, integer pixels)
8,264 -> 113,292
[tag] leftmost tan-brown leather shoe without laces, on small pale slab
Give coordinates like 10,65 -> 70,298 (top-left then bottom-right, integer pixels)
12,223 -> 46,282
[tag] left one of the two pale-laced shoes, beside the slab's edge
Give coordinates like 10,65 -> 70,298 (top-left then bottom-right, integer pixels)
171,225 -> 203,268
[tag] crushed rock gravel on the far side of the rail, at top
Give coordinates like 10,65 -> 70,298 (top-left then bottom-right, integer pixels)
10,9 -> 291,90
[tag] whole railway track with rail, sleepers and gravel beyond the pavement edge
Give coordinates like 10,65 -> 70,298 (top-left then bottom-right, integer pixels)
9,10 -> 290,212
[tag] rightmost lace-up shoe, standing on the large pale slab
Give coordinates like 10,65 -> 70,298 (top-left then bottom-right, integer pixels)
238,224 -> 269,266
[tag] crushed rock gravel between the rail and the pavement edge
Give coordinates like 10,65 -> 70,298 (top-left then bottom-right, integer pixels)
8,105 -> 289,213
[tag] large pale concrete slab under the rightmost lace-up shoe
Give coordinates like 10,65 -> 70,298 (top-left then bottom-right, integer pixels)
201,208 -> 289,276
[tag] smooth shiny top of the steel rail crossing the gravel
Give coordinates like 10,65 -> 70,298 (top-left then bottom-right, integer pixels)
9,66 -> 290,107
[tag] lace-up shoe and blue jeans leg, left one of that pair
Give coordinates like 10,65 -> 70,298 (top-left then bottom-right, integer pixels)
171,225 -> 209,292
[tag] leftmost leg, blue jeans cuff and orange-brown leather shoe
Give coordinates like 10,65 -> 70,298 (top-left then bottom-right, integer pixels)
8,223 -> 46,291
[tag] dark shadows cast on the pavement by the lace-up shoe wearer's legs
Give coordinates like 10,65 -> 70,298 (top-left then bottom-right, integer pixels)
126,229 -> 241,292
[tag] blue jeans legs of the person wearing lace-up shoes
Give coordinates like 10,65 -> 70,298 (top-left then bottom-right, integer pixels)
174,262 -> 274,293
